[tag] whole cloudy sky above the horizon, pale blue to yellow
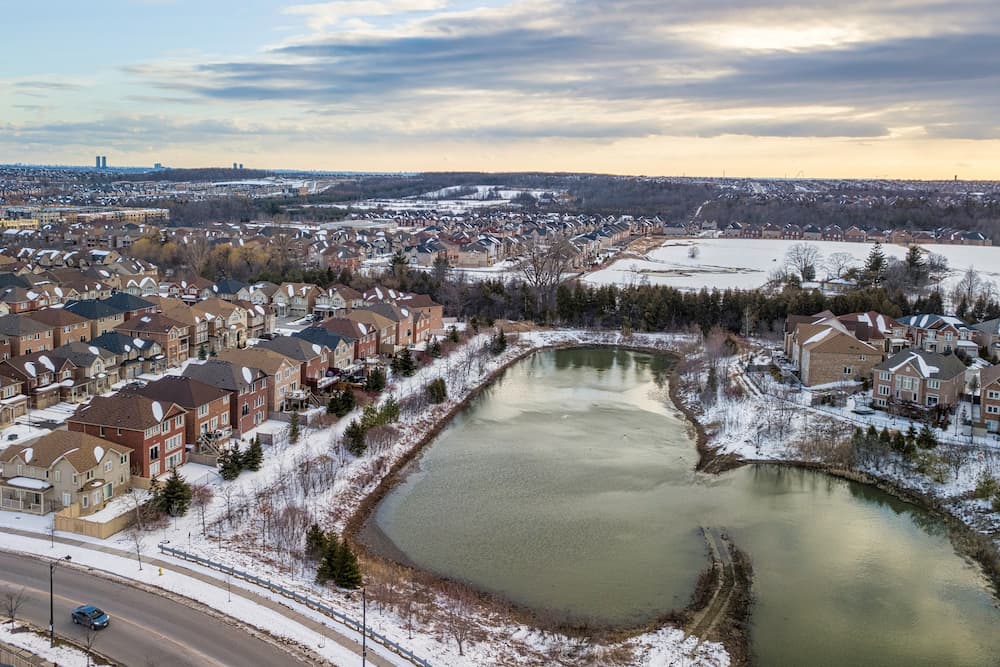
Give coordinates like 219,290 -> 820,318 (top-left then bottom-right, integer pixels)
0,0 -> 1000,180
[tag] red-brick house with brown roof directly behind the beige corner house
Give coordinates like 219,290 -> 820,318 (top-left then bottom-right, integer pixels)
66,394 -> 187,479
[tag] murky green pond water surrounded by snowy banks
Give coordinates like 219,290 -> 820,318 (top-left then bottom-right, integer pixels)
366,348 -> 1000,667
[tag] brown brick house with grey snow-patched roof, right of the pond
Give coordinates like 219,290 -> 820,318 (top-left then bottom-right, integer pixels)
872,349 -> 965,408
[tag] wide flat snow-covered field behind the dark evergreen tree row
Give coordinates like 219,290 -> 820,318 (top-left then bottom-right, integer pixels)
584,239 -> 1000,290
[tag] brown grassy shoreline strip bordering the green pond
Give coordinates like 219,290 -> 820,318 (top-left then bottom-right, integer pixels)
344,338 -> 1000,665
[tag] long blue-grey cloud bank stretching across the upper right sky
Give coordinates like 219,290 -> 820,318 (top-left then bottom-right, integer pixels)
123,0 -> 1000,138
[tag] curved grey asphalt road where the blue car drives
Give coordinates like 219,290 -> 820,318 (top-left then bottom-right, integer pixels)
0,552 -> 302,667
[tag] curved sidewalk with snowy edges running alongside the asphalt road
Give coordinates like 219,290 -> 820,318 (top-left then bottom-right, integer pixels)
0,528 -> 395,667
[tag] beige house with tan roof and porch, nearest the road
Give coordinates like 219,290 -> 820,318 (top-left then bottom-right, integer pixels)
0,431 -> 132,515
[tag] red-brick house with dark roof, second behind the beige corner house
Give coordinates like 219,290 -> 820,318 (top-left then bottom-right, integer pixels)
128,375 -> 233,451
